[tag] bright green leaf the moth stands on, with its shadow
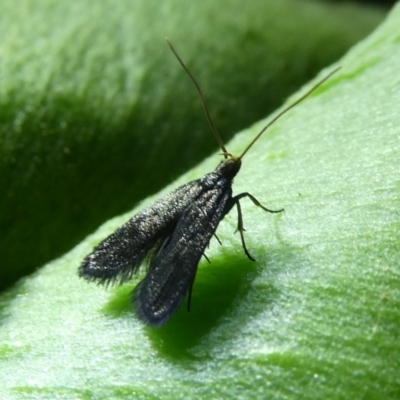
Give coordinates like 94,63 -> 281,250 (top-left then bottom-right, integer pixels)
0,5 -> 400,400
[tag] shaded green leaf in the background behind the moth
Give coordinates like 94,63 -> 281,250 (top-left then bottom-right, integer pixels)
0,0 -> 383,290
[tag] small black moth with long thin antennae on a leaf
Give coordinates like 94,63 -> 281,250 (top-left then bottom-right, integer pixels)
79,39 -> 337,326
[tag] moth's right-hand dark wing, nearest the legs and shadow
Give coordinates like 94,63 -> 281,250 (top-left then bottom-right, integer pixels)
133,185 -> 232,326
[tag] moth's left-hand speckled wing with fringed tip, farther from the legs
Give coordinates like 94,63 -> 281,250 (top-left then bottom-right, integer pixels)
79,181 -> 201,284
